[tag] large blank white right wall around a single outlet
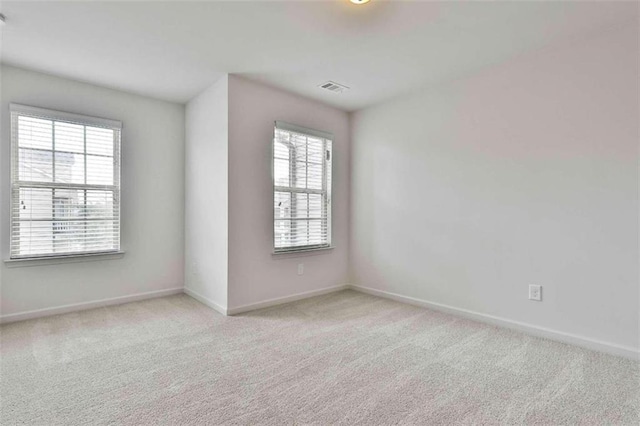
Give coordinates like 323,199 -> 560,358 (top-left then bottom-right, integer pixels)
351,26 -> 640,349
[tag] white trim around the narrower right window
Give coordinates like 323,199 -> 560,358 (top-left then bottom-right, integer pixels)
271,121 -> 335,255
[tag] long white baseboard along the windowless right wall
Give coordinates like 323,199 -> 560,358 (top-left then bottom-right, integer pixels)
348,285 -> 640,360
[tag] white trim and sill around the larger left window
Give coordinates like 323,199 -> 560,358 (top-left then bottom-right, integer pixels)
4,103 -> 125,266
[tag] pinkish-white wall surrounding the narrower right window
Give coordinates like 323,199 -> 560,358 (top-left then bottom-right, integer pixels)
229,76 -> 349,310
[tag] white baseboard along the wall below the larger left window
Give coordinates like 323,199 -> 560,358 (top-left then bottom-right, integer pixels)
0,287 -> 184,324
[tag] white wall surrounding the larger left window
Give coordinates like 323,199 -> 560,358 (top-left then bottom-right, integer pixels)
0,65 -> 184,316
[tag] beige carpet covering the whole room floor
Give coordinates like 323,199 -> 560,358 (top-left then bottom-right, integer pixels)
0,291 -> 640,425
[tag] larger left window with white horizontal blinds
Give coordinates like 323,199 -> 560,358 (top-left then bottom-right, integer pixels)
10,104 -> 122,259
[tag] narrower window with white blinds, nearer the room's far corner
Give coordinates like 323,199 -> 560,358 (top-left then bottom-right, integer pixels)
273,121 -> 333,253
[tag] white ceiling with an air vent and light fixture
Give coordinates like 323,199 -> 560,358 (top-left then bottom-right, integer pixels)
0,0 -> 638,110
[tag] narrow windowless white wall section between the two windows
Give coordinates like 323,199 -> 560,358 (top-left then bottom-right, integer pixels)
185,76 -> 229,309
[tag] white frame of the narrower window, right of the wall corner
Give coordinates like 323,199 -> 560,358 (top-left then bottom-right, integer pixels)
271,121 -> 334,254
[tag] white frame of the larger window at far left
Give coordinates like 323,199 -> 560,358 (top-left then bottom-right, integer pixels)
5,103 -> 124,264
